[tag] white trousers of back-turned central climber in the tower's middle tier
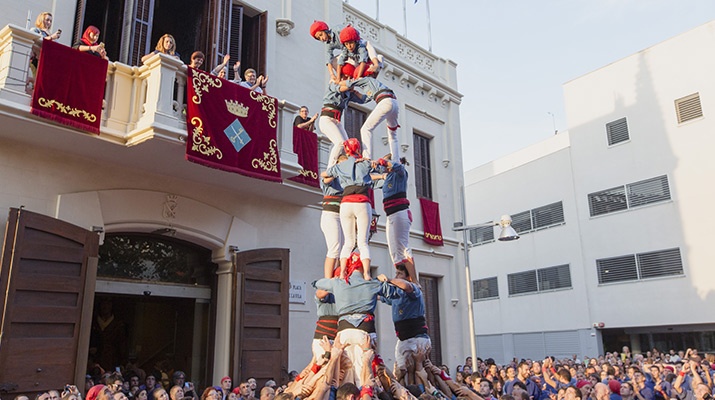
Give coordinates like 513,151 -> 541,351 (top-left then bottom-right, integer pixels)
340,202 -> 372,259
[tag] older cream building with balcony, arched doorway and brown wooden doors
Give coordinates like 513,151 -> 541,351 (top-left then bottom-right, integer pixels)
0,0 -> 469,393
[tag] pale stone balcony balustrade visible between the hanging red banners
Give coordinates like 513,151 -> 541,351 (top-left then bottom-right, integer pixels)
0,25 -> 329,205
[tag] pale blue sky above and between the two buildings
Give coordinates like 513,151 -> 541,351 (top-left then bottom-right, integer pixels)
347,0 -> 715,172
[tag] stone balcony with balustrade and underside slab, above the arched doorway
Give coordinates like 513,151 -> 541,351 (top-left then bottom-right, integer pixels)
0,25 -> 330,205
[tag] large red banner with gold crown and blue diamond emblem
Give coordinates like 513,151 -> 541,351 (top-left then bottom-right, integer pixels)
186,67 -> 282,182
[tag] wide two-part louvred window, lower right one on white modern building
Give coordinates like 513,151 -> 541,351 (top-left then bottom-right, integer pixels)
596,248 -> 684,283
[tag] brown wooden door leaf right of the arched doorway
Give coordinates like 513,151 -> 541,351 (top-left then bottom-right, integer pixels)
231,249 -> 290,387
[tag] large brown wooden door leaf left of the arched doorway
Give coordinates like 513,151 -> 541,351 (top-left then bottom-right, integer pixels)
0,208 -> 99,397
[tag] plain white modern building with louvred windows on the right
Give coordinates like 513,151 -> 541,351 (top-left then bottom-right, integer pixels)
465,22 -> 715,362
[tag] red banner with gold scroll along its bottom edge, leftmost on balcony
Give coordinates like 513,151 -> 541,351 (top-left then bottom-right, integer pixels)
30,40 -> 108,134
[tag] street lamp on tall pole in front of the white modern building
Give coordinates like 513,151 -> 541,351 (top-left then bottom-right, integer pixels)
452,186 -> 519,366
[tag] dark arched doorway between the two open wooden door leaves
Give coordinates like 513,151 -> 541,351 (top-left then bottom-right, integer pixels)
95,230 -> 217,387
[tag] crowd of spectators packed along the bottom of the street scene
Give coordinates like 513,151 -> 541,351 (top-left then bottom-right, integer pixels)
22,347 -> 715,400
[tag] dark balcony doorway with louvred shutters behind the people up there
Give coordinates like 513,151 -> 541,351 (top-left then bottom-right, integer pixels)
73,0 -> 267,69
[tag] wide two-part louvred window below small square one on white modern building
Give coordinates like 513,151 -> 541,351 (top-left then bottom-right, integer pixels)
588,175 -> 670,217
